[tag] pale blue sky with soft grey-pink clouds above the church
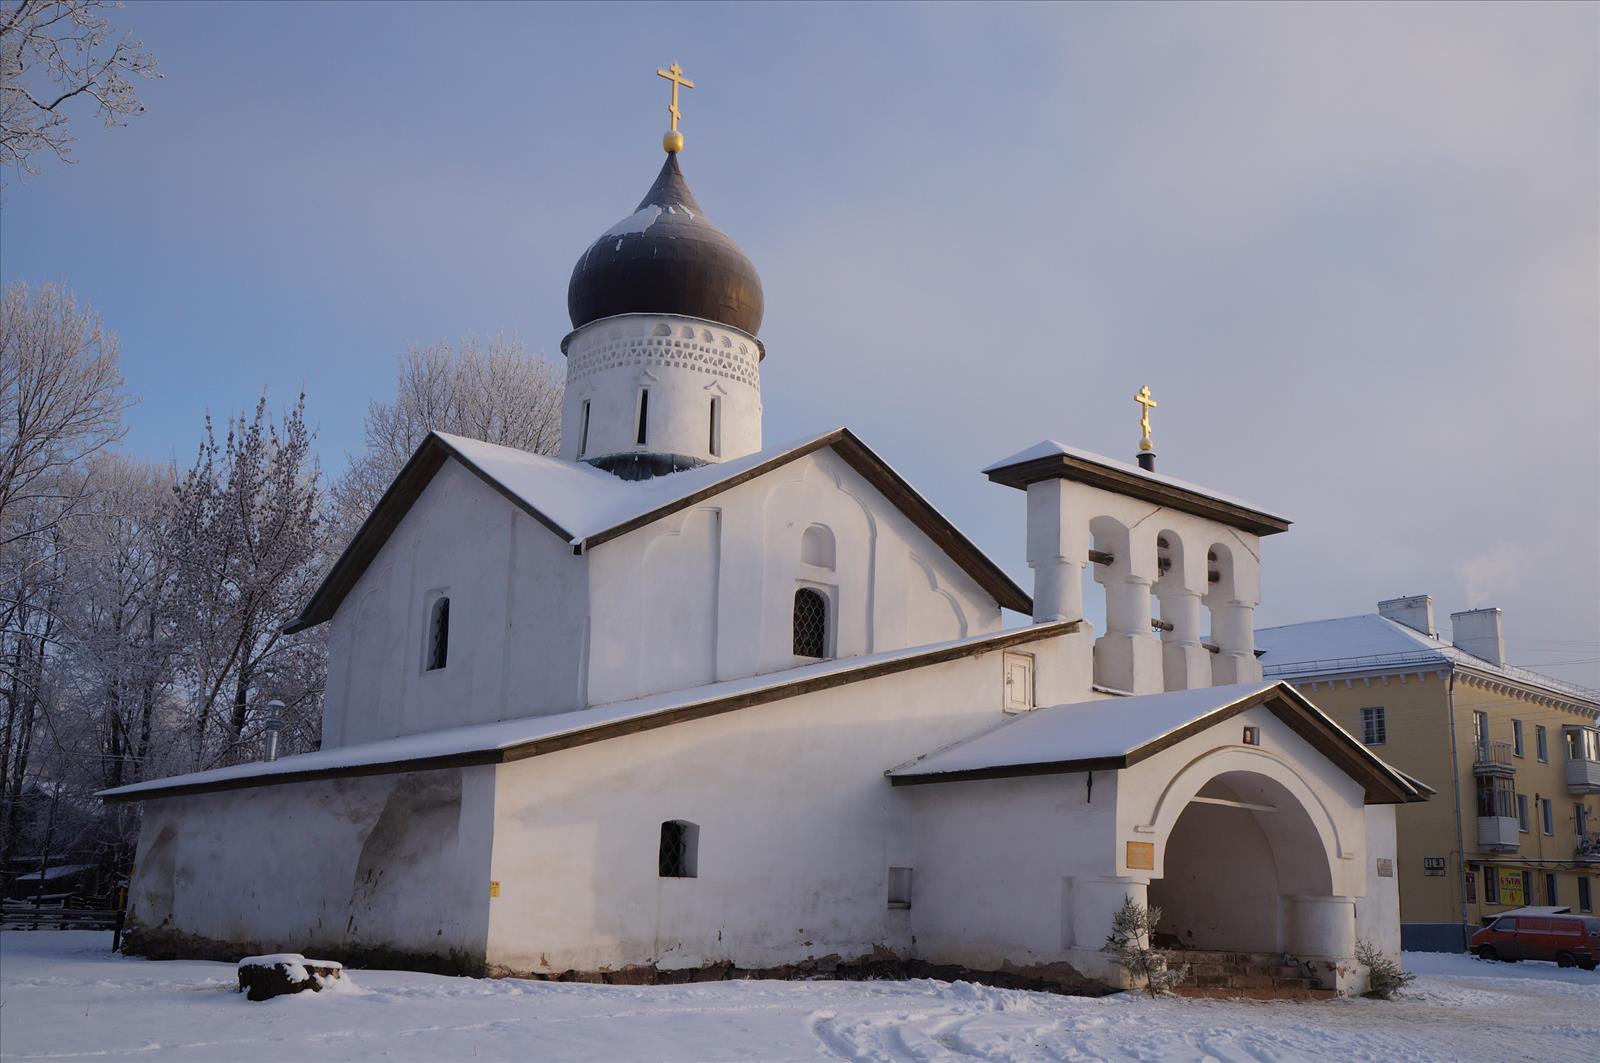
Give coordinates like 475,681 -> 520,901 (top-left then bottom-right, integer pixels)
0,0 -> 1600,687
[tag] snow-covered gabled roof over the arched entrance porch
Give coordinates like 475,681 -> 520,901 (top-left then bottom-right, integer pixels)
888,682 -> 1434,804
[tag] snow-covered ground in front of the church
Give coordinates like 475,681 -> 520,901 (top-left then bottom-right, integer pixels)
0,930 -> 1600,1063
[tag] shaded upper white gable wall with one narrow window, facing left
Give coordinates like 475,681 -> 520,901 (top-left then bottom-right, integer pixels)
323,459 -> 587,748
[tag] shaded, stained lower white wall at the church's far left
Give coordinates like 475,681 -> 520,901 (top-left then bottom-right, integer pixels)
128,767 -> 494,957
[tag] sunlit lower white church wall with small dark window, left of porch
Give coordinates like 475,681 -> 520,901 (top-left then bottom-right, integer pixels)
476,639 -> 1061,973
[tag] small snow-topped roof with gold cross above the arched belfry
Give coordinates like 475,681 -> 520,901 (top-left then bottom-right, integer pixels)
984,439 -> 1290,535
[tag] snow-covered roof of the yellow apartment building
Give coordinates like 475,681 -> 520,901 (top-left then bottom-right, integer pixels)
1256,613 -> 1600,711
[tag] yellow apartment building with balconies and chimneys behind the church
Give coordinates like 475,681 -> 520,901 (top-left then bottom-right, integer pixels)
1256,594 -> 1600,951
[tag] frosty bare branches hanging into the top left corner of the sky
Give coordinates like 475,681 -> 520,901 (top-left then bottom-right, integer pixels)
0,0 -> 160,174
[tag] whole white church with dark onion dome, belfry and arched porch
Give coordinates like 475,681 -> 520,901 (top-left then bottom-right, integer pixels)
104,70 -> 1429,993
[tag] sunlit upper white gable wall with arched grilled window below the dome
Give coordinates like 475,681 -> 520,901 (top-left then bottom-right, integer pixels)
589,450 -> 1000,704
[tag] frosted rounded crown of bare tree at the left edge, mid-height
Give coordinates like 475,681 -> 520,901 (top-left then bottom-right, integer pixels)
0,282 -> 130,549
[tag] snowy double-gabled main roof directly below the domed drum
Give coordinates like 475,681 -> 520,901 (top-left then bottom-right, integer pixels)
285,427 -> 1034,632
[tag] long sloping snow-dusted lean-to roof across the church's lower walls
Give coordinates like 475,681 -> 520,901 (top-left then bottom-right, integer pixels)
99,621 -> 1077,802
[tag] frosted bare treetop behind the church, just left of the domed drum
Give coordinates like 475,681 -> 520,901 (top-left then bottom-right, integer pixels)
333,336 -> 563,536
